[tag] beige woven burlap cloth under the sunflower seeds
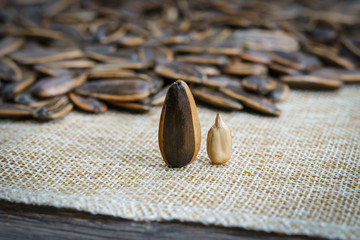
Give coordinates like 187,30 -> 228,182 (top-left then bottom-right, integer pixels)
0,86 -> 360,239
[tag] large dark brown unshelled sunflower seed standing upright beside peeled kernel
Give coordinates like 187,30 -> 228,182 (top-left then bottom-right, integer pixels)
159,80 -> 201,168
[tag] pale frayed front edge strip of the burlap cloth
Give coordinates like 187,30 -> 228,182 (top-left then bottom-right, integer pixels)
0,188 -> 360,239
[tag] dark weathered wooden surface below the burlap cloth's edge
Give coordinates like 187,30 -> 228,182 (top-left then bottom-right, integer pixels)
0,200 -> 319,240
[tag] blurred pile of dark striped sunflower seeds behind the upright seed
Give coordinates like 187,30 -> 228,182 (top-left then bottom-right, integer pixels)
0,0 -> 360,120
